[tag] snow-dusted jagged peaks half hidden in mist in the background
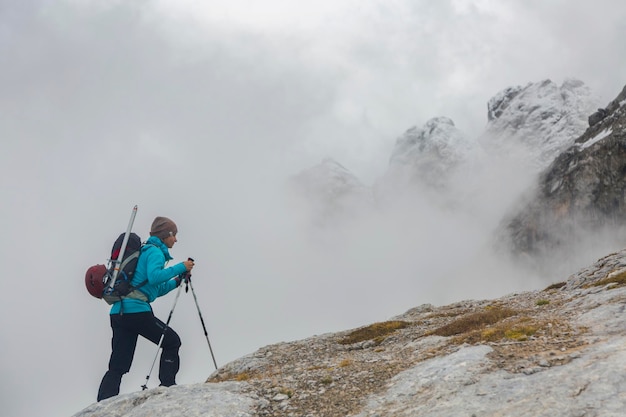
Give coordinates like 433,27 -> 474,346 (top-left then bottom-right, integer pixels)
291,80 -> 604,232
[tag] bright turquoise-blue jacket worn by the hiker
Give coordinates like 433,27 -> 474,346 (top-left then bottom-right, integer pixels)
110,236 -> 187,314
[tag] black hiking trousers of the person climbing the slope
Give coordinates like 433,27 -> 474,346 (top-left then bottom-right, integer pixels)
98,312 -> 180,401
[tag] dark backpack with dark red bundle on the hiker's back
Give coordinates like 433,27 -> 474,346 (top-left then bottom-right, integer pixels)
85,233 -> 148,304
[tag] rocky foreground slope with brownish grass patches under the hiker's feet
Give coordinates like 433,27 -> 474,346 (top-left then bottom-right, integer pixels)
74,250 -> 626,417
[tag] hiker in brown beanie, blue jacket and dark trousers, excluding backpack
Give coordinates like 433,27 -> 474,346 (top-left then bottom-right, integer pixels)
98,217 -> 194,401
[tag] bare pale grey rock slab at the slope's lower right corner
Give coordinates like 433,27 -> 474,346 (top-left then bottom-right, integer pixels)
358,290 -> 626,417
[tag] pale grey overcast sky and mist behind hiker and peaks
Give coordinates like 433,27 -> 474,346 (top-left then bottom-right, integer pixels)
0,0 -> 626,417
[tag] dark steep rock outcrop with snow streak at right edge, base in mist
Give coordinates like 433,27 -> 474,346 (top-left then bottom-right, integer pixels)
505,83 -> 626,274
